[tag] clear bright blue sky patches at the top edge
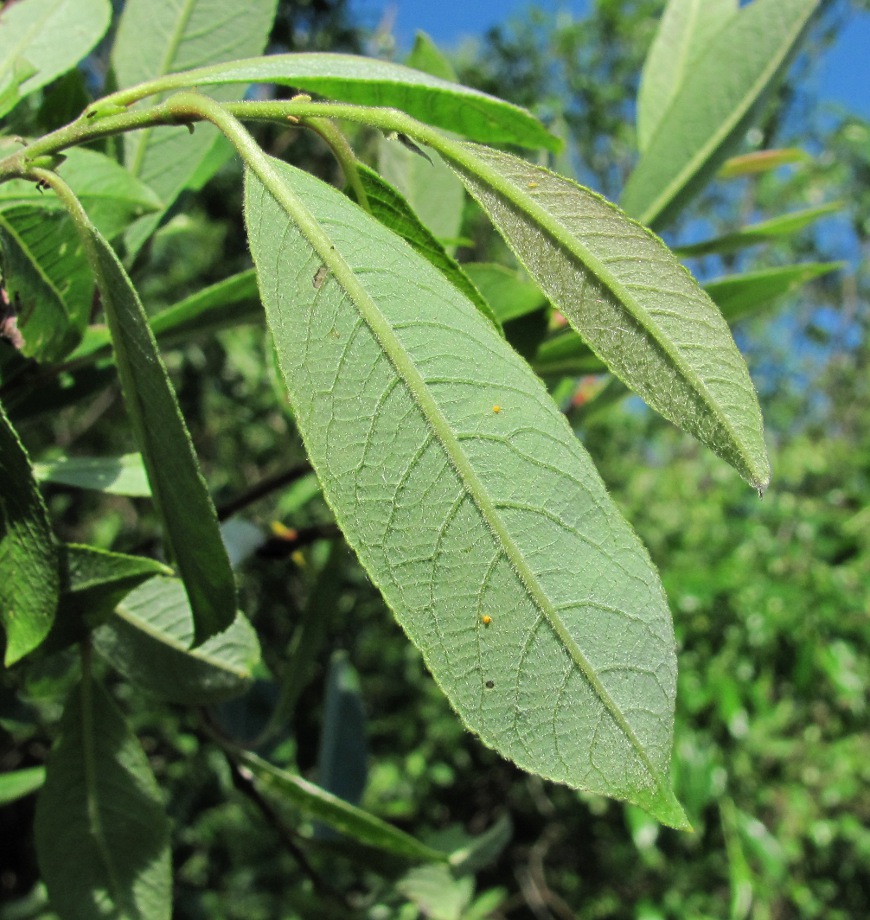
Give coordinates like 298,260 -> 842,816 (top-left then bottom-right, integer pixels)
351,0 -> 870,118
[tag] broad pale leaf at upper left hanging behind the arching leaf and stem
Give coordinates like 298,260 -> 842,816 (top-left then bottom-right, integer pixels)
112,0 -> 277,252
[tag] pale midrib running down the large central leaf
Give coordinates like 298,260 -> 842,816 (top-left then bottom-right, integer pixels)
246,153 -> 668,794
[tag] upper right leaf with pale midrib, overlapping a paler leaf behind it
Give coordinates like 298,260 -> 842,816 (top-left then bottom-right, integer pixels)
620,0 -> 818,226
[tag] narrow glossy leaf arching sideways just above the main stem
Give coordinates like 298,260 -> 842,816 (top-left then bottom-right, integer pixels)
95,53 -> 561,150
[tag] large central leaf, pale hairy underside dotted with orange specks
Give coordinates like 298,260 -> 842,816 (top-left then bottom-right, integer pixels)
245,154 -> 685,826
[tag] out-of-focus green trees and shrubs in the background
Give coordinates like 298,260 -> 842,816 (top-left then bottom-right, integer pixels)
0,0 -> 870,920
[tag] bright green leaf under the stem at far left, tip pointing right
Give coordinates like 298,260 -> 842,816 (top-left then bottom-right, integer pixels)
0,147 -> 161,239
